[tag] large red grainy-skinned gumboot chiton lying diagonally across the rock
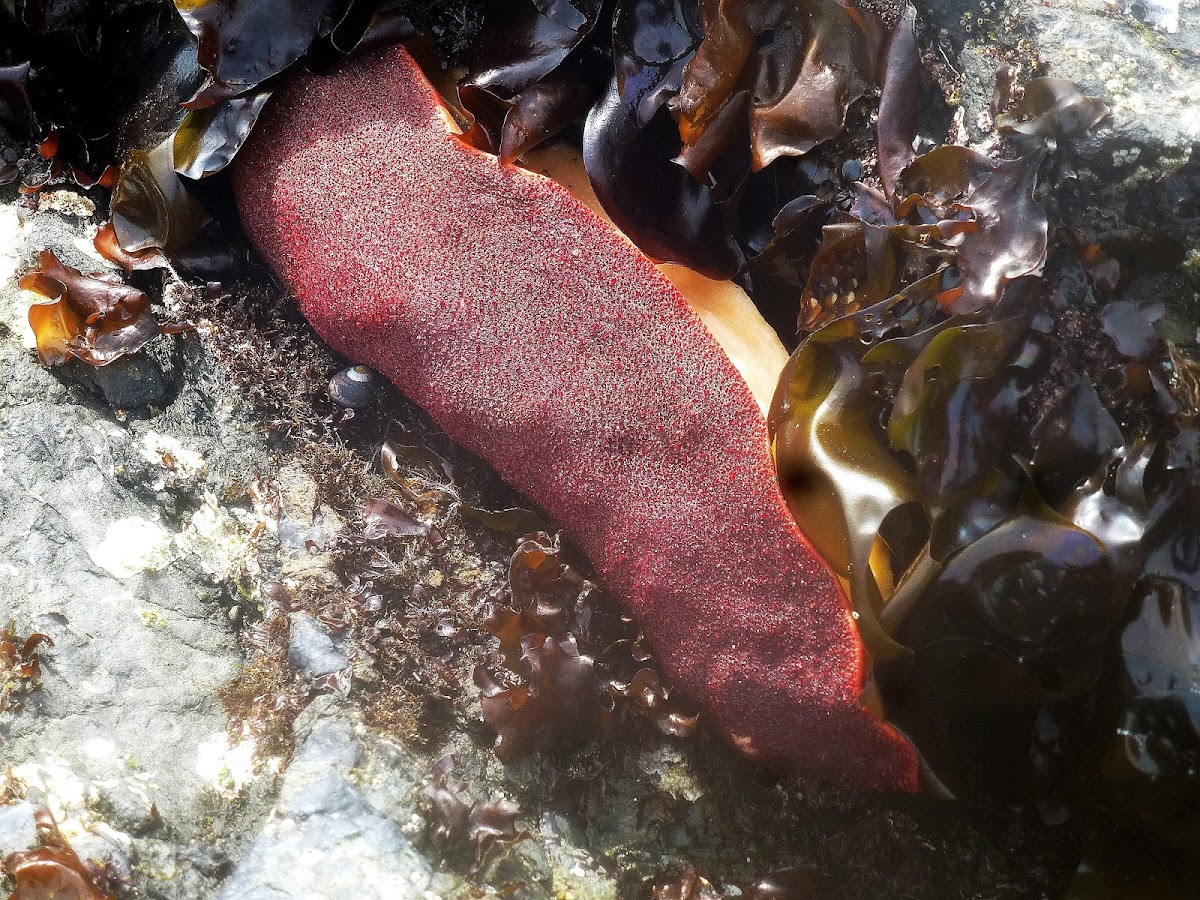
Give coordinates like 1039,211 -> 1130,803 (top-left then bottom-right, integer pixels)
235,48 -> 917,791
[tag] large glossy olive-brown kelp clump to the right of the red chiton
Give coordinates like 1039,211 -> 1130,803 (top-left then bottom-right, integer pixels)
772,79 -> 1200,890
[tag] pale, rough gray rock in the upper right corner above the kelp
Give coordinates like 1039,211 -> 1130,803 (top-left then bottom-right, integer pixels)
916,0 -> 1200,338
